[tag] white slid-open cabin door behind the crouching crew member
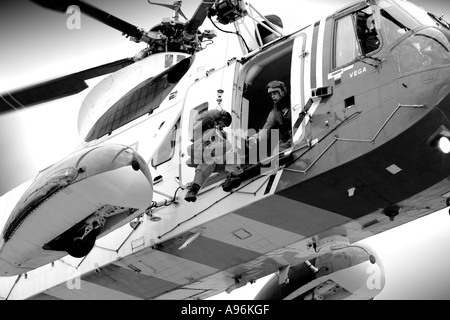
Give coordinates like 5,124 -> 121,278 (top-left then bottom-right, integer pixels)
180,60 -> 240,185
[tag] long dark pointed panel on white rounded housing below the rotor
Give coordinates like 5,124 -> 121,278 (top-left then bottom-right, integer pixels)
86,59 -> 190,141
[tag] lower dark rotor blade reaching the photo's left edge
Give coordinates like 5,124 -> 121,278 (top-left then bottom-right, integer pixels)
0,58 -> 134,114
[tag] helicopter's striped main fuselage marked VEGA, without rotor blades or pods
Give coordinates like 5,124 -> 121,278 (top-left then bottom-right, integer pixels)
0,1 -> 450,299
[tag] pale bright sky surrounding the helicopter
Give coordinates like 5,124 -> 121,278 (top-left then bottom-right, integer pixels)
0,0 -> 450,300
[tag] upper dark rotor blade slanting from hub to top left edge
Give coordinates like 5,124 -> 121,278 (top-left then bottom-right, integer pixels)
30,0 -> 143,40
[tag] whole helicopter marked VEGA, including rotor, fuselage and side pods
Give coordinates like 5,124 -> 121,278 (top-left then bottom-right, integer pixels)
0,0 -> 450,299
